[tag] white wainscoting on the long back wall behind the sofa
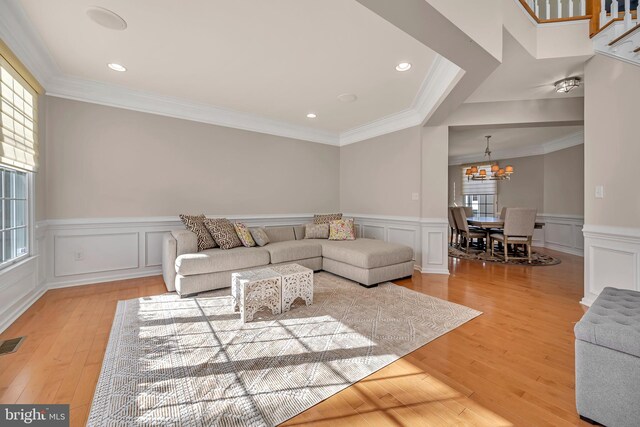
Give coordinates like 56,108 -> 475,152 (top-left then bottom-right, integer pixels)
38,214 -> 316,288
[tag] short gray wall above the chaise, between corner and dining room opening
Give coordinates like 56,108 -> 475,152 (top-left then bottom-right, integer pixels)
340,127 -> 421,217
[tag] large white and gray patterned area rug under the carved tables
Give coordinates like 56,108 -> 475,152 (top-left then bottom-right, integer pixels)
88,272 -> 481,427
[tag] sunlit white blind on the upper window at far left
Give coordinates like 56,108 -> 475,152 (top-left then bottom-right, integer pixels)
0,56 -> 38,172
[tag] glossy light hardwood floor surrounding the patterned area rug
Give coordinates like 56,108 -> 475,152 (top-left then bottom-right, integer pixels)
0,251 -> 586,426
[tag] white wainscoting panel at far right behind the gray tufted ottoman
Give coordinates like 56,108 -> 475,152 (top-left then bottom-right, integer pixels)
581,225 -> 640,306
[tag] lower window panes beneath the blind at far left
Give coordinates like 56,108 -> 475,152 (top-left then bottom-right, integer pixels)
0,166 -> 29,266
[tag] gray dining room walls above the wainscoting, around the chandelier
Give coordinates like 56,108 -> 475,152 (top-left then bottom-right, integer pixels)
448,145 -> 584,216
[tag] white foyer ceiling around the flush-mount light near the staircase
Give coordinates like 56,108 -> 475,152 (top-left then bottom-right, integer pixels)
466,31 -> 587,102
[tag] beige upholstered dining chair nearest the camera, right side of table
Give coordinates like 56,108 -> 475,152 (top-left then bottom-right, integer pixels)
489,208 -> 538,263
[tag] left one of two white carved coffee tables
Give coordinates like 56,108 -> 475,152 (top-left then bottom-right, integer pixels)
231,268 -> 282,323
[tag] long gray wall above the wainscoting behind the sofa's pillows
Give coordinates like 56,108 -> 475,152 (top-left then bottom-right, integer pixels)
43,97 -> 340,219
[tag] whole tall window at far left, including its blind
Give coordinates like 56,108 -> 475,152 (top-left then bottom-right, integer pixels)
0,51 -> 38,268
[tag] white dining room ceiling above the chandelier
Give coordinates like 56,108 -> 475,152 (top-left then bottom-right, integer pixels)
449,126 -> 584,164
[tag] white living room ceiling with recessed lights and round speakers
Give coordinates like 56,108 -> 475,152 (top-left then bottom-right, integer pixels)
21,0 -> 437,132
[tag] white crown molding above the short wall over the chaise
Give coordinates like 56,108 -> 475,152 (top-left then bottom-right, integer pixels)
340,55 -> 464,146
